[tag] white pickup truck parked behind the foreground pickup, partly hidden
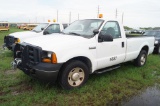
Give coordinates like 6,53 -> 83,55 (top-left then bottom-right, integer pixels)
3,23 -> 68,51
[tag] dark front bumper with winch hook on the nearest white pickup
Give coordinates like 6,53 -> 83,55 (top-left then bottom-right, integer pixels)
12,59 -> 62,83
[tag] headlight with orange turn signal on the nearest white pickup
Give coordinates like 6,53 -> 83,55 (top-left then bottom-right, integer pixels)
42,51 -> 57,64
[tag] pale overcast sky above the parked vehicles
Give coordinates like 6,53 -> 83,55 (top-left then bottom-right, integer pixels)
0,0 -> 160,28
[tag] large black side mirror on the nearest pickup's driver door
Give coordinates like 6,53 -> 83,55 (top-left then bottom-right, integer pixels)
98,34 -> 113,42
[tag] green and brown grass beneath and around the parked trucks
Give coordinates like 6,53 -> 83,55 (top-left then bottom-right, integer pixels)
0,28 -> 160,106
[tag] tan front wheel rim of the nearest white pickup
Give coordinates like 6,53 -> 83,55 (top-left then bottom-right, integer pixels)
68,67 -> 85,87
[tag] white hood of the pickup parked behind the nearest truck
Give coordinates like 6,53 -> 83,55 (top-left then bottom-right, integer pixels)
9,31 -> 41,42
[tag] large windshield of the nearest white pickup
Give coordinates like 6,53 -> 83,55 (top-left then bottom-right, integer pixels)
63,19 -> 104,37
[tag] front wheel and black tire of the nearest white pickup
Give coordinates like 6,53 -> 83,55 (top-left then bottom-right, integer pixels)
59,60 -> 89,90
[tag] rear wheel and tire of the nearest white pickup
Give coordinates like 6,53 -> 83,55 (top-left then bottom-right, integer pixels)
134,50 -> 147,67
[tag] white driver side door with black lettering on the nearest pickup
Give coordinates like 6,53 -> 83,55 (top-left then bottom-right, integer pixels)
97,21 -> 126,69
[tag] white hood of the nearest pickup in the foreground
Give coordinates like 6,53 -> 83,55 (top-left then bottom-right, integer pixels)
21,34 -> 93,51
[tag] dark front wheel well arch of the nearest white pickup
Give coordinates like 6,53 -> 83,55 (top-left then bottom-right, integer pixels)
62,56 -> 92,73
